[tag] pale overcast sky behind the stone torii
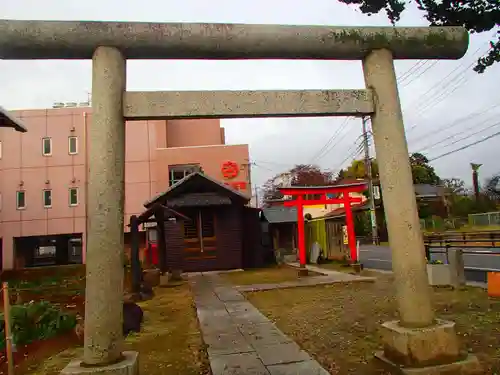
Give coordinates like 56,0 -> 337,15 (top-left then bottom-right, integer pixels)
0,0 -> 500,191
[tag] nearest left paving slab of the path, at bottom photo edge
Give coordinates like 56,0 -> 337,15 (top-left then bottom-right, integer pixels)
210,353 -> 269,375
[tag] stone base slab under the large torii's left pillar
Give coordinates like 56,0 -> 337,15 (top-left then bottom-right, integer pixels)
61,352 -> 139,375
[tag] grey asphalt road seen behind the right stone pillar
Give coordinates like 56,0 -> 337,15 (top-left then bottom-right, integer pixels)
359,245 -> 500,282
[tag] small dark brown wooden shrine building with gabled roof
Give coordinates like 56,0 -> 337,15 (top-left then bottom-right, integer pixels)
135,172 -> 263,272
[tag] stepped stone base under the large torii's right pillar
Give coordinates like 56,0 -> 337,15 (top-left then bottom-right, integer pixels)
375,319 -> 483,375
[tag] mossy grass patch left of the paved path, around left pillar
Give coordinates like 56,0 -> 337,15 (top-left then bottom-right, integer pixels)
31,284 -> 210,375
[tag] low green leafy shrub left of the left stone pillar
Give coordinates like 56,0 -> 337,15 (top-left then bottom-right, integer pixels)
0,301 -> 76,349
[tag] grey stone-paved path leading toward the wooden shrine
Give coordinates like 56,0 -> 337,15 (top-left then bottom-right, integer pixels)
189,273 -> 329,375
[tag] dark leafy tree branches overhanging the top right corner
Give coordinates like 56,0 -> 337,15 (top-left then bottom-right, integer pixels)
339,0 -> 500,73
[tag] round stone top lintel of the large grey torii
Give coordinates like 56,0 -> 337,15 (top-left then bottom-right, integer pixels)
0,20 -> 469,60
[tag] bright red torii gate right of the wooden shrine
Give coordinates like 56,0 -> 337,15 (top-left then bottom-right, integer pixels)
279,182 -> 367,268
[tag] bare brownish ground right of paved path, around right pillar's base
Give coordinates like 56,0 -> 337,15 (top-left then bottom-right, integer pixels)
247,273 -> 500,375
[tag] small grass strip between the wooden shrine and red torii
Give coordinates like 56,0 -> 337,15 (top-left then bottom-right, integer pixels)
220,265 -> 320,285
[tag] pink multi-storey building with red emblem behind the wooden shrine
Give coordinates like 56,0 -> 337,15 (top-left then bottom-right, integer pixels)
0,107 -> 251,269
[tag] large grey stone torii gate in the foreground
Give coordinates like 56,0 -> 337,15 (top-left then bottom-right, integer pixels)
0,20 -> 477,374
